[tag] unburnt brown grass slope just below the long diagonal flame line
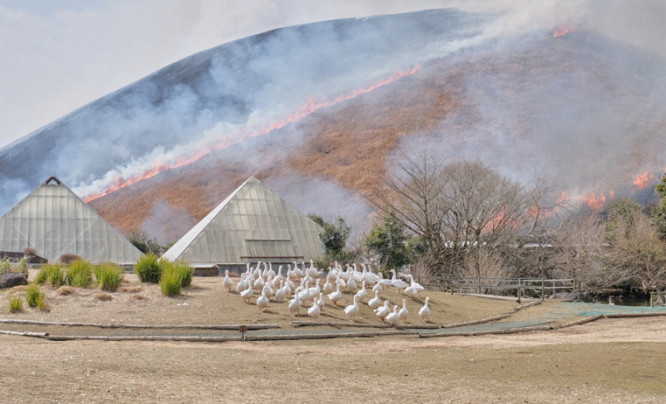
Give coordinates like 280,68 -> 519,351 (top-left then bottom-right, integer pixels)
91,62 -> 459,241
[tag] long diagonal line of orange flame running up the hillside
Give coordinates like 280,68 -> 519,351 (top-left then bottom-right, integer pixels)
84,64 -> 423,203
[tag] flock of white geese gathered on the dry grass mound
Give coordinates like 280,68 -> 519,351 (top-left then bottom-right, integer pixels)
222,261 -> 430,325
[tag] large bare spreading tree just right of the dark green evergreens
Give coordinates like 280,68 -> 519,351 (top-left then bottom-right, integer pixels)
370,155 -> 529,277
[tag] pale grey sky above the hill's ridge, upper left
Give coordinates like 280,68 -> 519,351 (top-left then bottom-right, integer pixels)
0,0 -> 471,148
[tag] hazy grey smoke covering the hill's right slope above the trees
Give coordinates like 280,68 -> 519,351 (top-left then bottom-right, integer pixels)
400,7 -> 666,202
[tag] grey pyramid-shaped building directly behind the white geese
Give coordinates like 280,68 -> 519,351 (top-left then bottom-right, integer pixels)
163,177 -> 324,269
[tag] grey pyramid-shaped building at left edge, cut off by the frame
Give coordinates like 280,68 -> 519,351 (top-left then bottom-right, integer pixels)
0,177 -> 143,265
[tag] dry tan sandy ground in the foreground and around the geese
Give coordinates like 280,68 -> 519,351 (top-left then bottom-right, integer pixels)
0,272 -> 666,403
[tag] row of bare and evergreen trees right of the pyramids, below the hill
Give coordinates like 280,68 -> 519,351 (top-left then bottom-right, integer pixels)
312,155 -> 666,293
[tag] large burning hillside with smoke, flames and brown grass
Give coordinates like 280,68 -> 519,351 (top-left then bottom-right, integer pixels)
0,10 -> 666,242
